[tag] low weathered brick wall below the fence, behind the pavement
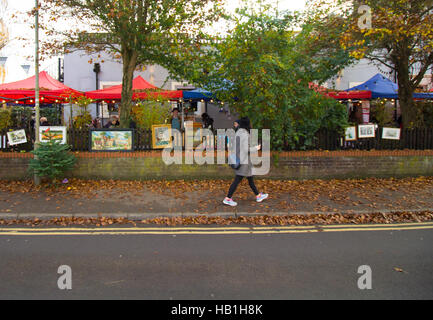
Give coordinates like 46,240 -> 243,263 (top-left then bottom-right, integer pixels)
0,151 -> 433,180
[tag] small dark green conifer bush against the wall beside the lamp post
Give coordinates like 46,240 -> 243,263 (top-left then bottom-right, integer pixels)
29,132 -> 77,181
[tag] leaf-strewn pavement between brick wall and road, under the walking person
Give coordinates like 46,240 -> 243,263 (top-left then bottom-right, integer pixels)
0,177 -> 433,220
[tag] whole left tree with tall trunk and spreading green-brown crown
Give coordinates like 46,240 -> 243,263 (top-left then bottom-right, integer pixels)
41,0 -> 225,127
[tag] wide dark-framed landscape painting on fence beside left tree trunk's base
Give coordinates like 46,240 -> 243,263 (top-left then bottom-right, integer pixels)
89,128 -> 134,152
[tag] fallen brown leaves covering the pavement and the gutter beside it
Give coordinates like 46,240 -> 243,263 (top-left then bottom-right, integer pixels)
0,177 -> 433,226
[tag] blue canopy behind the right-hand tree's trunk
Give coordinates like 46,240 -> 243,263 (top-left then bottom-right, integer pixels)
346,73 -> 433,99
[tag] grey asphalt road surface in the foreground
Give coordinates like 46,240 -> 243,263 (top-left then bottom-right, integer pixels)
0,225 -> 433,300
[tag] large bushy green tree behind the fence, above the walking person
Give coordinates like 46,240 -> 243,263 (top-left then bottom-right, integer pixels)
187,2 -> 352,149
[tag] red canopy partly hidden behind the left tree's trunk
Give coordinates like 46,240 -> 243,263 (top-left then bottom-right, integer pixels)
86,76 -> 183,100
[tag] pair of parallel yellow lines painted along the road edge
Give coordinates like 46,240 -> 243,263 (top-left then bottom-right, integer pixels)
0,222 -> 433,236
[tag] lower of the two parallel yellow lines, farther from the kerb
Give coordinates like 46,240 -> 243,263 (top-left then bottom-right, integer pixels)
0,224 -> 433,236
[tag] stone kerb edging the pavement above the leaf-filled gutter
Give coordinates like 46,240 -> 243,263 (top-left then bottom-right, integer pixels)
0,208 -> 433,221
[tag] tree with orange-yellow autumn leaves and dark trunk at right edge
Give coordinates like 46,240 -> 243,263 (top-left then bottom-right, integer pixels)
322,0 -> 433,128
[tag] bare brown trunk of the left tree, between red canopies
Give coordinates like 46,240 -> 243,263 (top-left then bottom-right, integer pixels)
120,50 -> 137,128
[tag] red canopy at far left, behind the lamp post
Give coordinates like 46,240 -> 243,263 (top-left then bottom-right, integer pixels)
0,71 -> 83,104
